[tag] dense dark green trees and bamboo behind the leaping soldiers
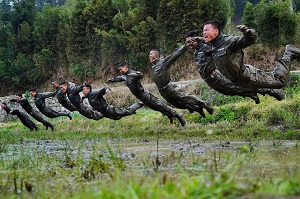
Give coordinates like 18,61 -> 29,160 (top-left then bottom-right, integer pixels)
0,0 -> 300,95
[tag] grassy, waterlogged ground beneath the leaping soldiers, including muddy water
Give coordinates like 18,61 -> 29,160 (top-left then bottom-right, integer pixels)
0,76 -> 300,199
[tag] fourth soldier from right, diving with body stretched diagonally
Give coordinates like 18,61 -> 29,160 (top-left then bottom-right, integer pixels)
107,63 -> 185,126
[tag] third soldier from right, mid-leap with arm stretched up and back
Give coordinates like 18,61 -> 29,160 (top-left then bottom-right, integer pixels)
149,45 -> 213,117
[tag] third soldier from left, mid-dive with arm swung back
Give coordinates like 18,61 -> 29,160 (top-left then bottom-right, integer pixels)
29,89 -> 72,120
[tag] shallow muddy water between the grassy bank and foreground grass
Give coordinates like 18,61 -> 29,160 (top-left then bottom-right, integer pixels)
0,139 -> 300,179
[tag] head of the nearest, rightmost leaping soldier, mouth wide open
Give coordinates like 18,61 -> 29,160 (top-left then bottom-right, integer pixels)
203,20 -> 221,43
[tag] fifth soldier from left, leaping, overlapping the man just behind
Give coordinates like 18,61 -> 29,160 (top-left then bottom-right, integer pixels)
60,82 -> 104,120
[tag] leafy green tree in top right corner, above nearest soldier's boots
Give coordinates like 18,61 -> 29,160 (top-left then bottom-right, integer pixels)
243,0 -> 299,46
